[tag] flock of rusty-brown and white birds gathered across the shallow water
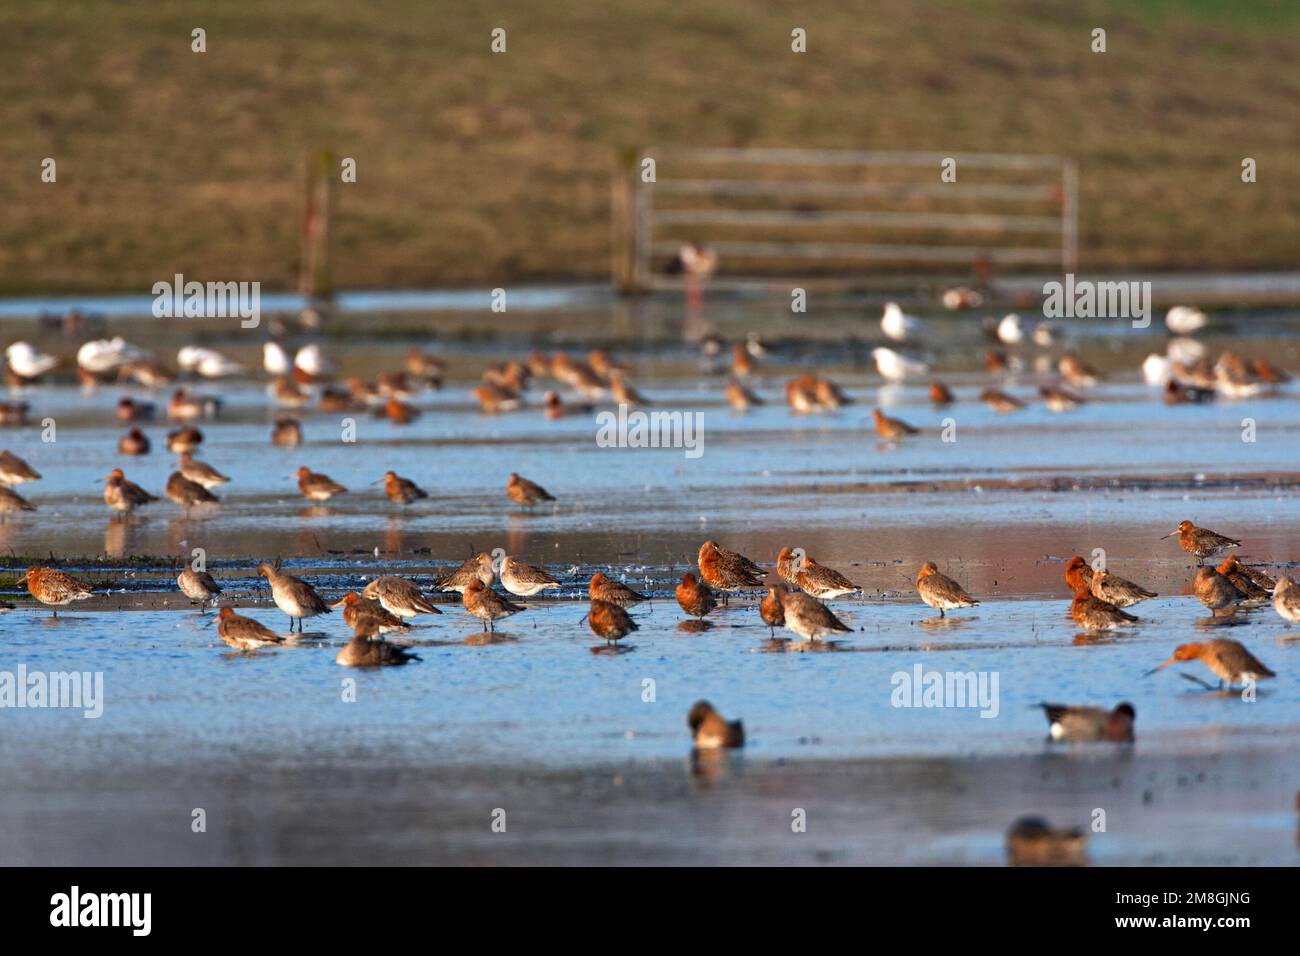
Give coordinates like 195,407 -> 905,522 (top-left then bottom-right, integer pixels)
0,310 -> 1300,764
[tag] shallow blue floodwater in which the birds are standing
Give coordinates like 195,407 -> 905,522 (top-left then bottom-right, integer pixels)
0,300 -> 1300,865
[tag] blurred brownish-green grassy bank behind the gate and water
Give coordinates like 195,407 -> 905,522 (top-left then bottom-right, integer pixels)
0,0 -> 1300,293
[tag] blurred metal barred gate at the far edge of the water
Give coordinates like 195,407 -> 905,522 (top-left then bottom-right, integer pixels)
614,148 -> 1078,290
